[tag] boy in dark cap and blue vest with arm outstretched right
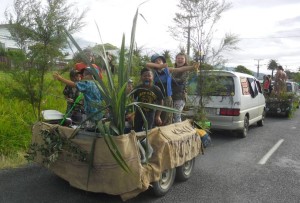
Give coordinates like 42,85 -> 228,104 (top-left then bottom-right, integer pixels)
146,54 -> 199,125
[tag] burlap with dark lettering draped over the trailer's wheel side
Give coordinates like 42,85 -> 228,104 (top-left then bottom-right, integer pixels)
143,120 -> 203,183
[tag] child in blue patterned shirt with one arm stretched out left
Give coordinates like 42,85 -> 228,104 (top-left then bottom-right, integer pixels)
53,68 -> 103,130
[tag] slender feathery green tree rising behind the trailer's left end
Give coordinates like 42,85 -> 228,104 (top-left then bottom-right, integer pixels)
6,0 -> 84,120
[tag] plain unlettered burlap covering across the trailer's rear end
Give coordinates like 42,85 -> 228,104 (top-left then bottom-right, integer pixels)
32,123 -> 148,200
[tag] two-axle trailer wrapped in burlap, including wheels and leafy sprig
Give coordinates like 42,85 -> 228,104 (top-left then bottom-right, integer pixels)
29,120 -> 203,201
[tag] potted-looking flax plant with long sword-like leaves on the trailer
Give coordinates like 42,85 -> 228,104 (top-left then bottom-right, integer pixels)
65,9 -> 179,171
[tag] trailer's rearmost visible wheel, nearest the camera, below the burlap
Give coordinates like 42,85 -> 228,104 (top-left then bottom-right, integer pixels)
152,168 -> 176,197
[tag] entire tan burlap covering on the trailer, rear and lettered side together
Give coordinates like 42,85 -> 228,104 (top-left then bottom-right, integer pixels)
32,121 -> 203,200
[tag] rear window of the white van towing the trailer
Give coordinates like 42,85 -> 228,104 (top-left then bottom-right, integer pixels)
188,75 -> 235,96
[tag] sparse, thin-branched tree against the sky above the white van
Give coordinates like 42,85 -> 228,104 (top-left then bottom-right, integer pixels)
169,0 -> 239,65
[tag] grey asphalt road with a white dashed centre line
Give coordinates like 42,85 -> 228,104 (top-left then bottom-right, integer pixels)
0,110 -> 300,203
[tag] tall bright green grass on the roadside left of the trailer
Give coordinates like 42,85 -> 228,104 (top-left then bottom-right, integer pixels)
0,71 -> 66,169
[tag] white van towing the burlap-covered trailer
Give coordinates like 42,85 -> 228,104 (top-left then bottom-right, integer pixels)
186,70 -> 266,137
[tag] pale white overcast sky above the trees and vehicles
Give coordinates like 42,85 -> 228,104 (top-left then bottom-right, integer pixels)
0,0 -> 300,73
